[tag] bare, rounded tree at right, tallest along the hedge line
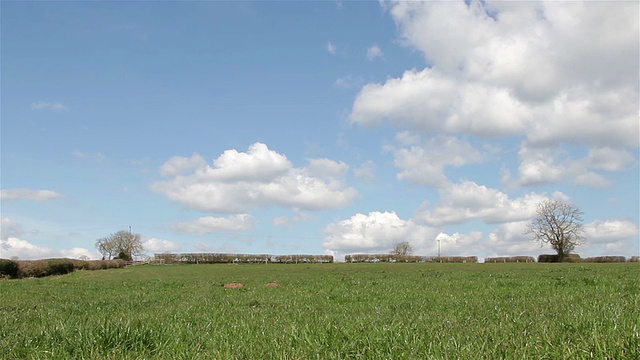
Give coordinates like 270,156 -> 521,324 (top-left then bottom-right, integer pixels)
525,200 -> 584,262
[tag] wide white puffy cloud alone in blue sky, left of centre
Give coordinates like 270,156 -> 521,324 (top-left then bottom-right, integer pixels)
151,143 -> 358,214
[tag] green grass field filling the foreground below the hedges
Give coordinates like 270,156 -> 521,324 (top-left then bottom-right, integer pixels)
0,263 -> 640,359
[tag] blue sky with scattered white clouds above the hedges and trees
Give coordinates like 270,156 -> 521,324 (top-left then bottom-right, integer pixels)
0,1 -> 640,259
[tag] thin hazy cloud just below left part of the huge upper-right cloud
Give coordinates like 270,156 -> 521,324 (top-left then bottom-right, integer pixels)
387,133 -> 483,187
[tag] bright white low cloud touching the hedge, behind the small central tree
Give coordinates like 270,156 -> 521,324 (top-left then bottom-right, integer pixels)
323,211 -> 435,254
